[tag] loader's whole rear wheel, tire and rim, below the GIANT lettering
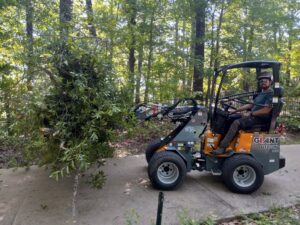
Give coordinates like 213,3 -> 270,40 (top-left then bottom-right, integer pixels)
222,155 -> 264,194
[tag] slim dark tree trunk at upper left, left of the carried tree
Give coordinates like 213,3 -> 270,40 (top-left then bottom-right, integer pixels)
26,0 -> 34,90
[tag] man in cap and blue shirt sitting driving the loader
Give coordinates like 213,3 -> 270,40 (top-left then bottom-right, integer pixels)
213,72 -> 274,155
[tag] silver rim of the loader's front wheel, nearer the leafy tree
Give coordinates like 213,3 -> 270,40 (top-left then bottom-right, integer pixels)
157,162 -> 179,184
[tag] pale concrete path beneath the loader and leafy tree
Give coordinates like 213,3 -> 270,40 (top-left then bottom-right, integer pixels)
0,145 -> 300,225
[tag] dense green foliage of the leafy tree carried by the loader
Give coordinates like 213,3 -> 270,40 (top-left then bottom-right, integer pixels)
34,46 -> 122,180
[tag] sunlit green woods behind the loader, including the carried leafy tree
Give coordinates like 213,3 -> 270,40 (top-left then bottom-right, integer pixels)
0,0 -> 300,176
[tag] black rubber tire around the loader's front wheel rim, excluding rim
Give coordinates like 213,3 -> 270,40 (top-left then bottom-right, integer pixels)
148,151 -> 186,190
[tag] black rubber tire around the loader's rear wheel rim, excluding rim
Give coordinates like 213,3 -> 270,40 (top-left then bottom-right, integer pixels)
222,154 -> 264,194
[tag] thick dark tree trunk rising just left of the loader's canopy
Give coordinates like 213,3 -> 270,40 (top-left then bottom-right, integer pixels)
193,0 -> 206,100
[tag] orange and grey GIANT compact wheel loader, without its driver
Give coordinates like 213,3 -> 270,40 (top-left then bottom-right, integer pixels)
134,61 -> 285,193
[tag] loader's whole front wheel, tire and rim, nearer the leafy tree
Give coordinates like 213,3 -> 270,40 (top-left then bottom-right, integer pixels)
148,152 -> 186,190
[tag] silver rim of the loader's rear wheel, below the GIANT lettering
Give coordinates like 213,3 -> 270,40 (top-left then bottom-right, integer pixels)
233,165 -> 256,188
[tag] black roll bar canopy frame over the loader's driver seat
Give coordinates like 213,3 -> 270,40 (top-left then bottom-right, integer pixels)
209,60 -> 282,132
